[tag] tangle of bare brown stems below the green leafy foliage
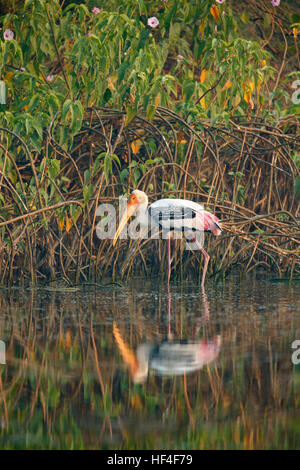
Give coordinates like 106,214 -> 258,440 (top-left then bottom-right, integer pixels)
0,107 -> 300,283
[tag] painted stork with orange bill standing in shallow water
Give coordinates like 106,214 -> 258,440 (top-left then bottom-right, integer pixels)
113,189 -> 222,287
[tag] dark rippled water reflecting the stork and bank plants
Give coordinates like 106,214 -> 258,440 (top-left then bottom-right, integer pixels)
0,273 -> 300,449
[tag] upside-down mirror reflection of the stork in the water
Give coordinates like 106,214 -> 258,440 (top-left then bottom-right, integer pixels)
113,290 -> 221,383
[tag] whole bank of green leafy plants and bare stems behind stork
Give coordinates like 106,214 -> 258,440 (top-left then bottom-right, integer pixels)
0,0 -> 300,285
